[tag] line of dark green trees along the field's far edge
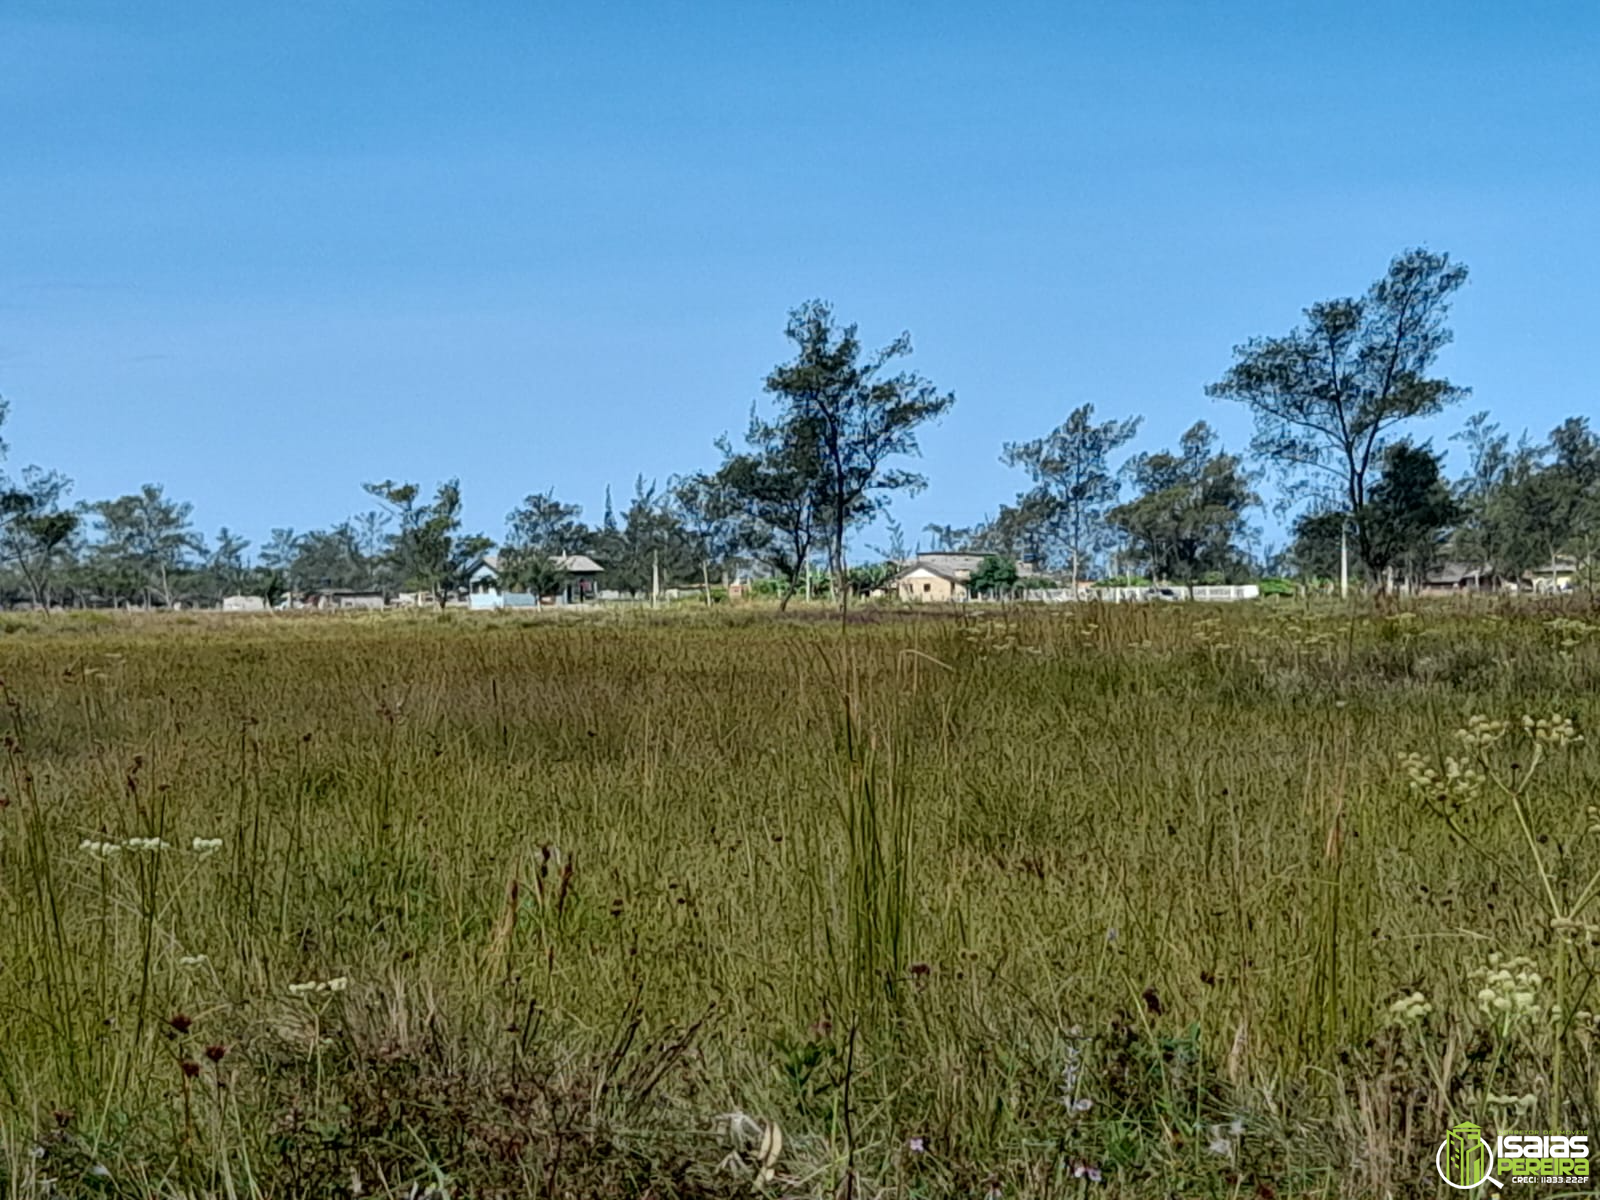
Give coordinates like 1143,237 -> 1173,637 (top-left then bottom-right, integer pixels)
0,250 -> 1600,606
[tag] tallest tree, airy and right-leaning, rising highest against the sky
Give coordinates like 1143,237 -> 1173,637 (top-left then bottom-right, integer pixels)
1206,250 -> 1467,574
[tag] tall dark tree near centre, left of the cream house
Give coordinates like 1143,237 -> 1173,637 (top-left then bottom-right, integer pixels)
766,301 -> 955,603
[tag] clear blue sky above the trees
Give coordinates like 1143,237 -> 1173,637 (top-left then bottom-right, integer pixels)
0,0 -> 1600,560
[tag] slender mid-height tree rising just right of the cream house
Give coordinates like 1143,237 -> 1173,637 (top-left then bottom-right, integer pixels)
1000,405 -> 1139,587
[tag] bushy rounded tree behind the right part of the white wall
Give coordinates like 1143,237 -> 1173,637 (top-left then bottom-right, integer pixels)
1107,421 -> 1261,584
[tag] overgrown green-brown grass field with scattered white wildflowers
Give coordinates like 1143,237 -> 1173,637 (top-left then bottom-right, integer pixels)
0,602 -> 1600,1200
